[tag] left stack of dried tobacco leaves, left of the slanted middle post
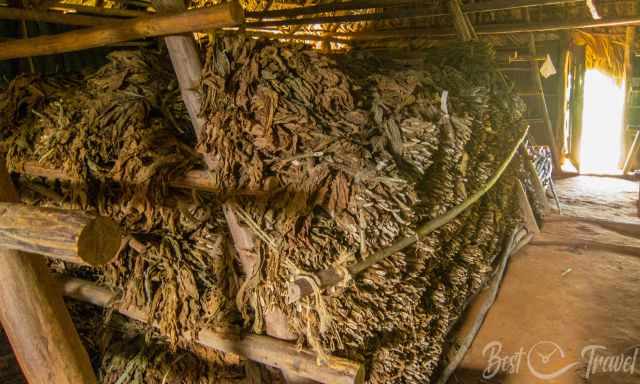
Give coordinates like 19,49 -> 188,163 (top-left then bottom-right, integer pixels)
0,47 -> 240,348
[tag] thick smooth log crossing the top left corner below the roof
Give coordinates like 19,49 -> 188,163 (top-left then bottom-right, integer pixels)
0,2 -> 244,60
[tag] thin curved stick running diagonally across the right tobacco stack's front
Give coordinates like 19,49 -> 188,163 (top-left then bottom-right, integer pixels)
288,130 -> 528,303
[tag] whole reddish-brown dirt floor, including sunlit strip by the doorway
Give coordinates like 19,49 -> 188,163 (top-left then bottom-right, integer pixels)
449,177 -> 640,384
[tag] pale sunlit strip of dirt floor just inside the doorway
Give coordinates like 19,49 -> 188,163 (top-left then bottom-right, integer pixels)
553,176 -> 640,224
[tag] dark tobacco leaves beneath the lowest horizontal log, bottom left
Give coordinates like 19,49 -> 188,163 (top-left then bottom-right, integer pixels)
67,300 -> 251,384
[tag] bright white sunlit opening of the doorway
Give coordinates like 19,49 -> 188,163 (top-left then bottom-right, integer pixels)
580,69 -> 624,173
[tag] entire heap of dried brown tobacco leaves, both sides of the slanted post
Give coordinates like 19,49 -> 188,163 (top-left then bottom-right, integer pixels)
0,36 -> 526,383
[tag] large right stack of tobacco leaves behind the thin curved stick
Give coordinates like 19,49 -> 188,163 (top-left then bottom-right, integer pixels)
199,36 -> 525,383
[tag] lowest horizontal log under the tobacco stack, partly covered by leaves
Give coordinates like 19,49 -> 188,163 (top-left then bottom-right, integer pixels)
59,277 -> 364,384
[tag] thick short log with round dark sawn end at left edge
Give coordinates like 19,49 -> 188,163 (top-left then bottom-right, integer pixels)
0,203 -> 122,266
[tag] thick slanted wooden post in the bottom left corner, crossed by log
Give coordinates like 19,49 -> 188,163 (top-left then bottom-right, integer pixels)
0,162 -> 97,384
